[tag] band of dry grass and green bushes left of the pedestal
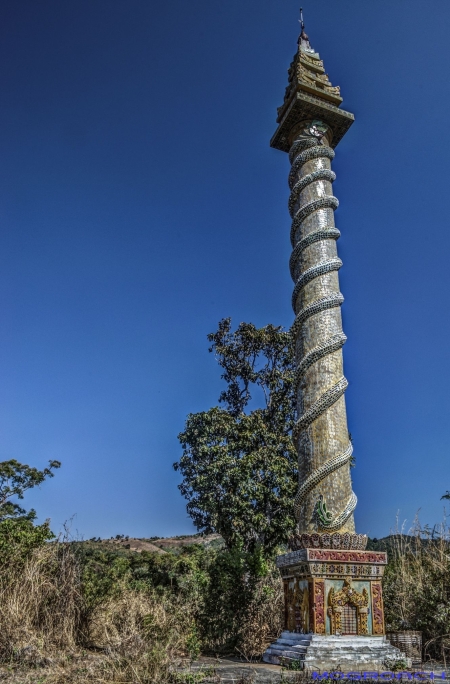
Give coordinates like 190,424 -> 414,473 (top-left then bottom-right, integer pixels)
0,521 -> 282,684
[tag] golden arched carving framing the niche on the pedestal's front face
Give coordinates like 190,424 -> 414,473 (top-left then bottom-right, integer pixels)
328,578 -> 369,635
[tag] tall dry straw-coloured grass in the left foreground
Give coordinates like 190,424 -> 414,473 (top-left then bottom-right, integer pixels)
0,543 -> 200,684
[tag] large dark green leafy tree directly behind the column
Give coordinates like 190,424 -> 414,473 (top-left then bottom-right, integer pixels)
174,318 -> 297,555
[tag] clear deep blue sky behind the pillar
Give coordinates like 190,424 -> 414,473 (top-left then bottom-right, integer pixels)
0,0 -> 450,537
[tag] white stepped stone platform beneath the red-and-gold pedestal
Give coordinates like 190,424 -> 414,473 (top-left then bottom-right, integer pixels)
263,631 -> 410,672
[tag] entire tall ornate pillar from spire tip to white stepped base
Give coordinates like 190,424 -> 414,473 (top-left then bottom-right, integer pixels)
264,17 -> 401,670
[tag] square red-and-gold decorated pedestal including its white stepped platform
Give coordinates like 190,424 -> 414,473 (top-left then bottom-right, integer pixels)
263,548 -> 405,670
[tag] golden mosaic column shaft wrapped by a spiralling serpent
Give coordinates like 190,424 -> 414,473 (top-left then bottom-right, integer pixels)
289,121 -> 356,533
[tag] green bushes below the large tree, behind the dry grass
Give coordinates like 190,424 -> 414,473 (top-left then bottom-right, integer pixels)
73,543 -> 280,657
